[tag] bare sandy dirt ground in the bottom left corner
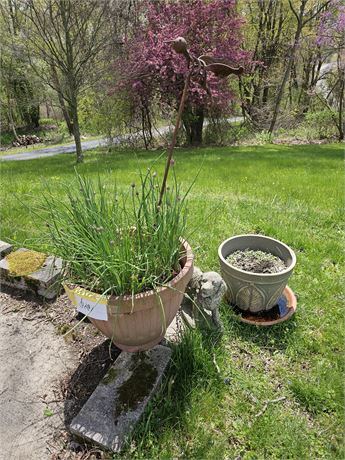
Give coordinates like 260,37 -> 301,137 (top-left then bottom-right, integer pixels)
0,287 -> 119,460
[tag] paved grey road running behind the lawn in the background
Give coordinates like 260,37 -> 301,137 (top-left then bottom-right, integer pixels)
0,117 -> 242,161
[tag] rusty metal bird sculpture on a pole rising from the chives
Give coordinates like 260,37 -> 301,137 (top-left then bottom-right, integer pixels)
157,37 -> 243,207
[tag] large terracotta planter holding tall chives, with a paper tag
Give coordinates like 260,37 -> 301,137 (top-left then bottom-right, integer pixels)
65,241 -> 193,352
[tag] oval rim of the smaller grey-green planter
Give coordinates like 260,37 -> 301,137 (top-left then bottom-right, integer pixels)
218,233 -> 296,280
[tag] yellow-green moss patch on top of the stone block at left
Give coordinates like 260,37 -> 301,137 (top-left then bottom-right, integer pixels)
6,251 -> 47,276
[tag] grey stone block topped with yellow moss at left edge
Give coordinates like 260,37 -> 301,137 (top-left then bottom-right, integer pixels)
0,248 -> 62,299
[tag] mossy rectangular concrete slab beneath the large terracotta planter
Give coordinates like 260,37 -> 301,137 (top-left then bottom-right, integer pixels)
70,345 -> 171,452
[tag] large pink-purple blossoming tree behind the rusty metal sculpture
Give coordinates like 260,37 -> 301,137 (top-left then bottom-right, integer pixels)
116,0 -> 250,144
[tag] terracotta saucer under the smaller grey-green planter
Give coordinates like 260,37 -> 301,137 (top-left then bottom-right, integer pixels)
228,286 -> 297,326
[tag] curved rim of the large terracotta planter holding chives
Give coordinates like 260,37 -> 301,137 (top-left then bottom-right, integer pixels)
64,239 -> 194,314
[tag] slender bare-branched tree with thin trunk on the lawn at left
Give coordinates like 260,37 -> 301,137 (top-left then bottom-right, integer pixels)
21,0 -> 109,162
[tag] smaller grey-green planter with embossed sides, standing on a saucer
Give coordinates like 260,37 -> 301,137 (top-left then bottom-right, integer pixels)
218,235 -> 296,313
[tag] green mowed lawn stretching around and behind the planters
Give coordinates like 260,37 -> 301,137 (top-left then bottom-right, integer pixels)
1,145 -> 344,459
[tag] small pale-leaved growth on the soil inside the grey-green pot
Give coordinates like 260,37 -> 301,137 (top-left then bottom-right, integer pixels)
226,249 -> 286,273
